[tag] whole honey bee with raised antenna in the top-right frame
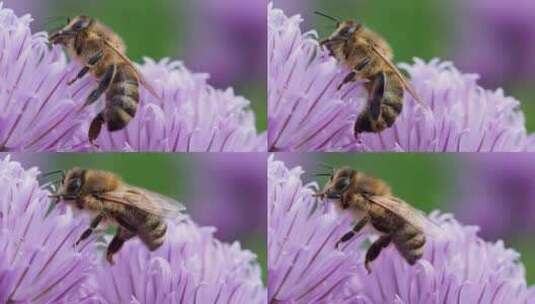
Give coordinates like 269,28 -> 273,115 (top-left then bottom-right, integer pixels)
315,12 -> 421,138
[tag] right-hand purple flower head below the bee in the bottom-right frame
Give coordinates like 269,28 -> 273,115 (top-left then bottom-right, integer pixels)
348,212 -> 535,304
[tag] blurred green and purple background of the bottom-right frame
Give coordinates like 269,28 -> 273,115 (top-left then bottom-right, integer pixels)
276,153 -> 535,284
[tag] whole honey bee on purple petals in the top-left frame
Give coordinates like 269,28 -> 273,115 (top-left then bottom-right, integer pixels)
49,16 -> 159,143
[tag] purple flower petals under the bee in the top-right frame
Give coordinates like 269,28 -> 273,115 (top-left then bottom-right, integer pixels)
268,5 -> 533,152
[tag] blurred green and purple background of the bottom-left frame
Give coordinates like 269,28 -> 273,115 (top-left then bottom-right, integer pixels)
8,153 -> 267,282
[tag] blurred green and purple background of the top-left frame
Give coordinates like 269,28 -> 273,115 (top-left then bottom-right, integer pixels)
3,0 -> 267,131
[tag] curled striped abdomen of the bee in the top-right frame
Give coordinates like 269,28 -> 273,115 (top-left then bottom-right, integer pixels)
354,71 -> 403,134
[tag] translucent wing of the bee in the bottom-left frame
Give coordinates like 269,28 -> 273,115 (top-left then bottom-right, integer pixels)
94,185 -> 186,219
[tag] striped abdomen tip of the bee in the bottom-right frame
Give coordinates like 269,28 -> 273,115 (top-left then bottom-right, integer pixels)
392,224 -> 425,265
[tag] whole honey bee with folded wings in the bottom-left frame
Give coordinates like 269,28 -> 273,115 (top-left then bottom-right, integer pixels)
50,168 -> 185,265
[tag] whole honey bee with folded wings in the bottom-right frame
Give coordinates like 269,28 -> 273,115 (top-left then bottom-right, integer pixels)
314,167 -> 441,273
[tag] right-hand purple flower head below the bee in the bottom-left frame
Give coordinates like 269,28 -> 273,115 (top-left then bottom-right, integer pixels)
86,221 -> 266,304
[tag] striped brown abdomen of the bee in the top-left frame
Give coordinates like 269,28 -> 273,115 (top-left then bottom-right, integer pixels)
103,63 -> 139,132
